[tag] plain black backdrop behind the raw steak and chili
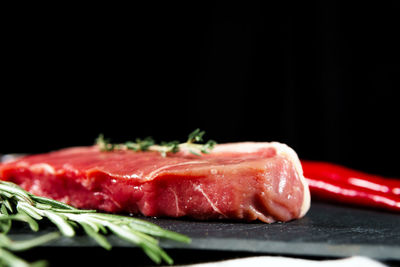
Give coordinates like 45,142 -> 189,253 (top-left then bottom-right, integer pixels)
0,0 -> 400,177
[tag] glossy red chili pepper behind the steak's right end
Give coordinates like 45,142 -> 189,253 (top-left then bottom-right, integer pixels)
302,160 -> 400,212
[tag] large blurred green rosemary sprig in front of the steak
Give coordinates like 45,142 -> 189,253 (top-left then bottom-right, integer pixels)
0,181 -> 190,266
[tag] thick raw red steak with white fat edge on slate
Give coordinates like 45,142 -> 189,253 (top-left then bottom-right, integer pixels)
0,142 -> 310,223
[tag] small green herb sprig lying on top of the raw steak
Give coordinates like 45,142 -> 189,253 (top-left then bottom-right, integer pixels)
95,129 -> 216,157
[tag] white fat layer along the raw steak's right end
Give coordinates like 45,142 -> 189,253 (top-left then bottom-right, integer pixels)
212,142 -> 311,217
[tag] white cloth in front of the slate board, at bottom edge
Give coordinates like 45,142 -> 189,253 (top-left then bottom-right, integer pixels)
180,256 -> 386,267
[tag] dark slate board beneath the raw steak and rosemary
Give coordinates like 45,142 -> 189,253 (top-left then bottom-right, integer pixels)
11,202 -> 400,262
